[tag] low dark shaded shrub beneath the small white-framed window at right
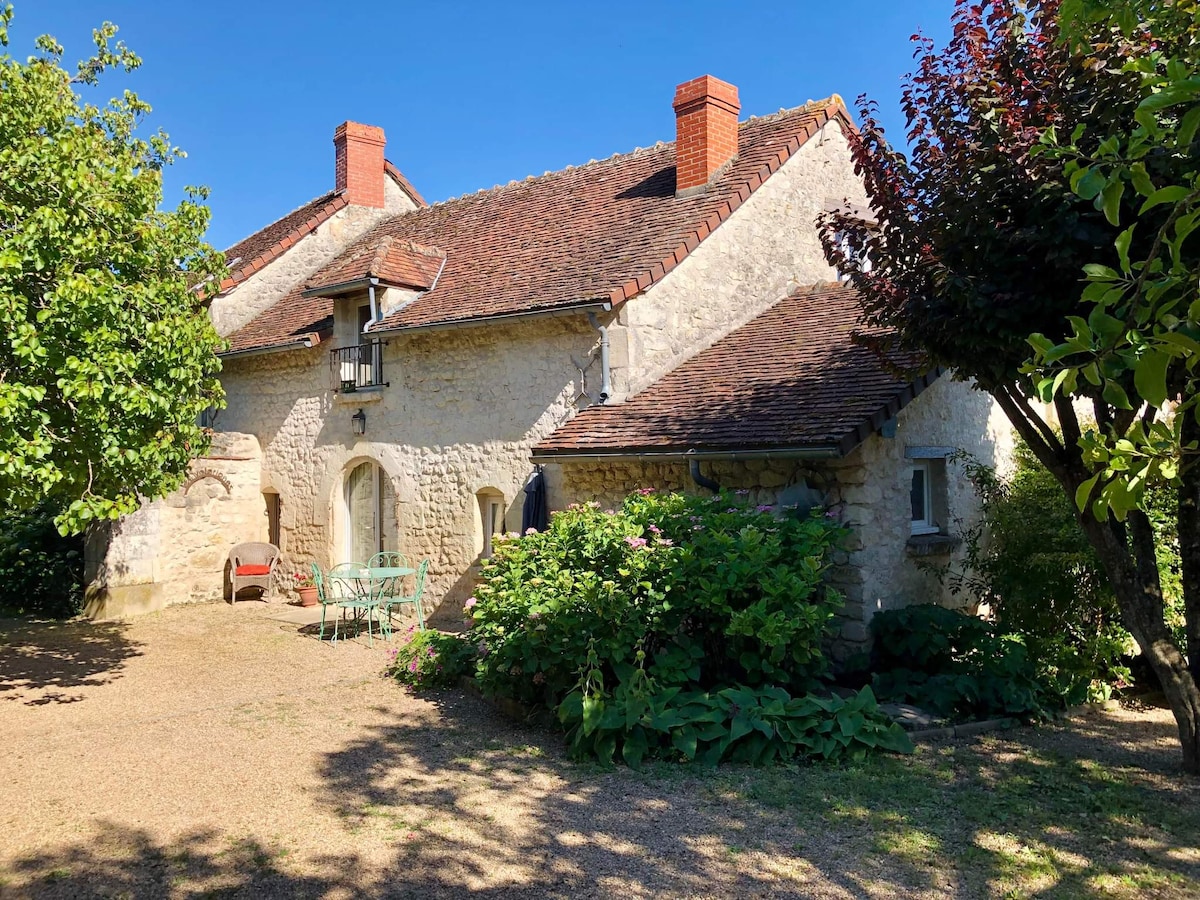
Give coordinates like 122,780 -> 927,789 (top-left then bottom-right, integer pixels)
871,605 -> 1069,720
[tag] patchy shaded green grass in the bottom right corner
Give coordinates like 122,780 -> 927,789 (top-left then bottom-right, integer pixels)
701,739 -> 1200,900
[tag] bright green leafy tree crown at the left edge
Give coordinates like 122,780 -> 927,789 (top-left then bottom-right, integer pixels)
0,6 -> 223,532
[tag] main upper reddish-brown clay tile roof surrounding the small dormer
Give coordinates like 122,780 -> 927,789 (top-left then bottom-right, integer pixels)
229,97 -> 851,352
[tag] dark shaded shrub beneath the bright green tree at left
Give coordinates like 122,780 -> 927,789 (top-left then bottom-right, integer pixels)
0,508 -> 83,618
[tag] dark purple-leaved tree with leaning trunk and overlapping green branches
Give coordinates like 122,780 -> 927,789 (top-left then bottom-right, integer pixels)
823,0 -> 1200,772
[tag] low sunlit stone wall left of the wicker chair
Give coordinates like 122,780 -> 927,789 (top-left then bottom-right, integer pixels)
84,433 -> 268,619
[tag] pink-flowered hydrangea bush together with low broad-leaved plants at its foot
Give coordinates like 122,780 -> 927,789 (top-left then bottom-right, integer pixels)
467,491 -> 911,766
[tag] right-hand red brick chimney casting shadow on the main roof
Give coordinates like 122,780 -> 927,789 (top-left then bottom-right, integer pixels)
672,76 -> 742,196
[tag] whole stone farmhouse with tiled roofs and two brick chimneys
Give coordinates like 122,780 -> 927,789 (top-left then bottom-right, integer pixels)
82,76 -> 1009,644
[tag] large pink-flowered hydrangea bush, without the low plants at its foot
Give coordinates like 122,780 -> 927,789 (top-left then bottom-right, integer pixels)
468,492 -> 842,709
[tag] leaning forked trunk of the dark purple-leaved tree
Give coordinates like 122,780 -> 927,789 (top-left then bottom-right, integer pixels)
1080,511 -> 1200,775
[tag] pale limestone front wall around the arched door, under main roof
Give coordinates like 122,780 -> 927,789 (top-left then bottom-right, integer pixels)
220,317 -> 595,616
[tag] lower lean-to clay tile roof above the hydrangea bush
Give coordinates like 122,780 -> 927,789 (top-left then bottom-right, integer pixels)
534,284 -> 932,458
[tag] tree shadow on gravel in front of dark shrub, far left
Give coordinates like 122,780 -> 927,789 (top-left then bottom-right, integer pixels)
0,620 -> 142,706
